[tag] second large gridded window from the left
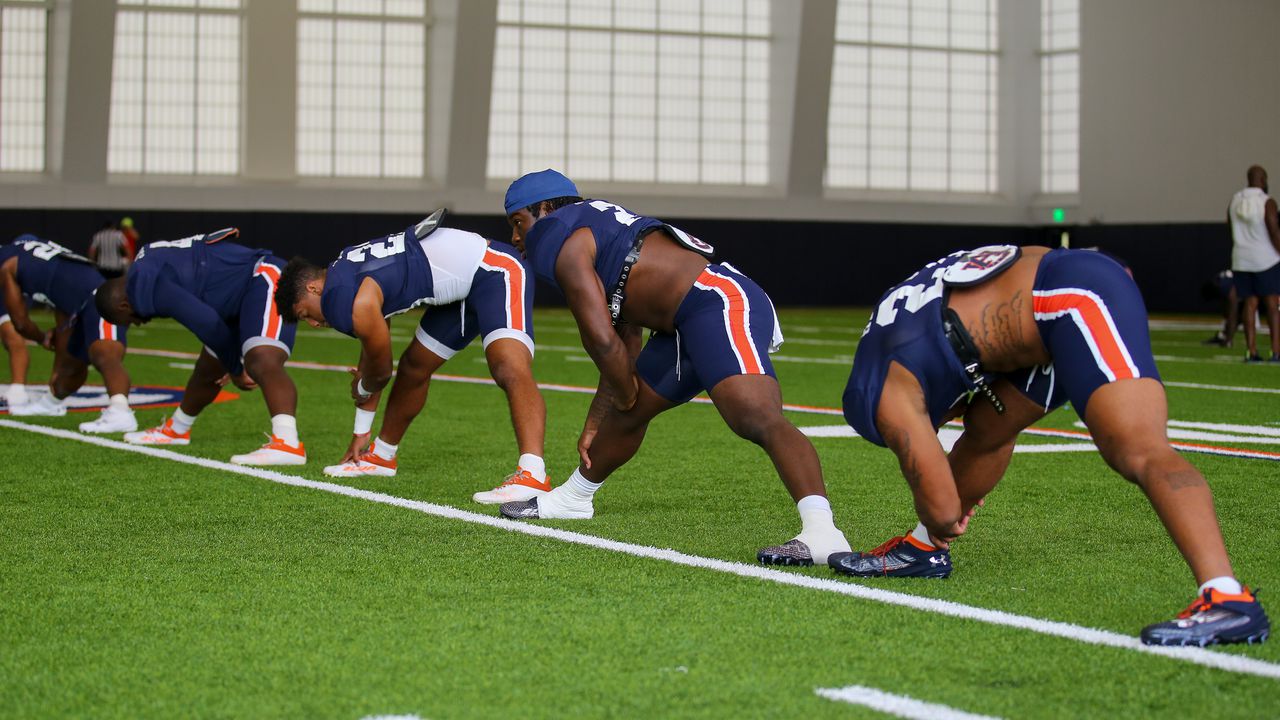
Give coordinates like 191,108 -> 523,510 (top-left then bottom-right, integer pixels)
106,0 -> 242,176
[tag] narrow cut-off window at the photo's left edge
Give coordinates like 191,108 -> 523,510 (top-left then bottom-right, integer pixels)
0,0 -> 49,173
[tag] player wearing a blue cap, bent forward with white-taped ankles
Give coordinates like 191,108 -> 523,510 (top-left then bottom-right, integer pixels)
502,170 -> 849,565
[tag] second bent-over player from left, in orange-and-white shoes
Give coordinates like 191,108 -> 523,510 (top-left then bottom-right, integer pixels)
97,228 -> 307,465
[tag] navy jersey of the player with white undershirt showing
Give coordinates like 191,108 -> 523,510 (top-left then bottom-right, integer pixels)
320,225 -> 435,337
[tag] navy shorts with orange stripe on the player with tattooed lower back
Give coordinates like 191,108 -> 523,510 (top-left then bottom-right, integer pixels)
1006,250 -> 1160,420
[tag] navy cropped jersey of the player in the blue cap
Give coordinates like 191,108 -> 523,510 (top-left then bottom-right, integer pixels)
525,200 -> 663,292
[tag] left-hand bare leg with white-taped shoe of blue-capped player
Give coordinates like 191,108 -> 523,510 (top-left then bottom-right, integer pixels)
502,378 -> 676,519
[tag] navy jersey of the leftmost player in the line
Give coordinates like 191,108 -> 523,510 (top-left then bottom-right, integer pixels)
0,236 -> 104,315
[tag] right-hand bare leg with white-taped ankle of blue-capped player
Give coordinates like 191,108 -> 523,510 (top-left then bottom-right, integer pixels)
708,375 -> 849,565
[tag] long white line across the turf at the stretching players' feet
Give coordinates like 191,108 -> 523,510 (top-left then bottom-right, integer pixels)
0,419 -> 1280,680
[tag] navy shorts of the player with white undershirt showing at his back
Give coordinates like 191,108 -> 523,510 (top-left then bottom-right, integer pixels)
413,242 -> 534,360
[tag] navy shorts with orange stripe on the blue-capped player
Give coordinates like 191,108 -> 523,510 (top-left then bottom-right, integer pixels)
636,265 -> 778,404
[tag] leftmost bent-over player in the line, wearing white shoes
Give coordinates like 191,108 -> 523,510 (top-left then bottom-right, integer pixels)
0,234 -> 138,433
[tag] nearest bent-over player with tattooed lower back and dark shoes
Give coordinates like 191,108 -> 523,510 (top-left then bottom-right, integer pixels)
829,246 -> 1271,646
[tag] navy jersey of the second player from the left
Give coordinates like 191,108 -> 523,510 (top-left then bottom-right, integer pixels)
125,234 -> 270,374
